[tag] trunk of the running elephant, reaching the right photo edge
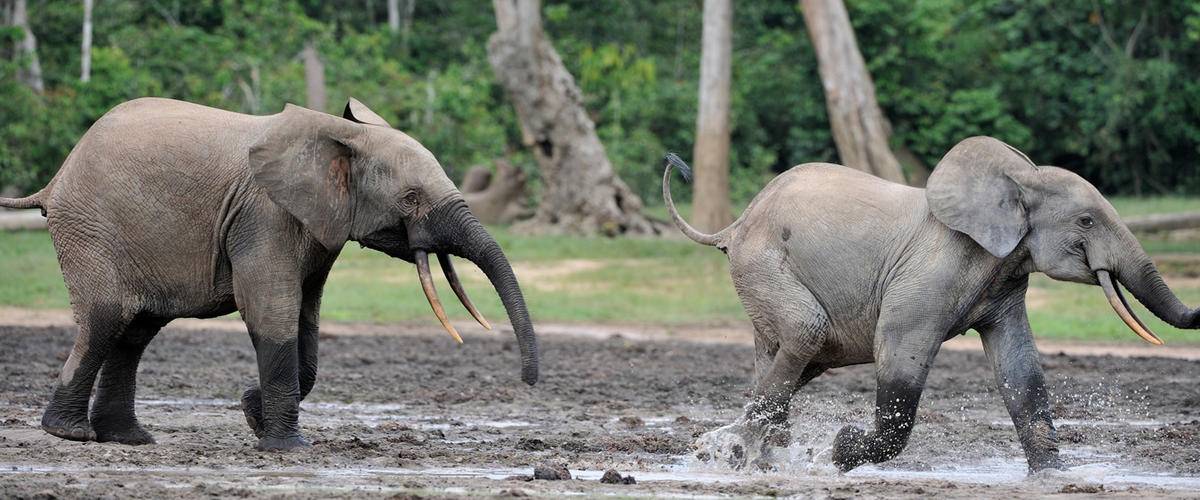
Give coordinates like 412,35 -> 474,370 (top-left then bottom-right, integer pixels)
1102,230 -> 1200,329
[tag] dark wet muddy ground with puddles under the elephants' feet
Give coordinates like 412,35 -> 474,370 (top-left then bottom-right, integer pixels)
0,326 -> 1200,498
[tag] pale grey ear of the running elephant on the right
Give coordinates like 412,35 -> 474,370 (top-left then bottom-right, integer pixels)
925,137 -> 1037,258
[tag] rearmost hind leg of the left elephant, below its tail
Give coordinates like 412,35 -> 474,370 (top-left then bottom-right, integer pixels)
42,299 -> 127,441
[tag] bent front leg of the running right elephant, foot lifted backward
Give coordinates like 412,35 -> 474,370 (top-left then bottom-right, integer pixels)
833,301 -> 948,472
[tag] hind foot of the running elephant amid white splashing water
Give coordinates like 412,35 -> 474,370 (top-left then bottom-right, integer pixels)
695,418 -> 791,471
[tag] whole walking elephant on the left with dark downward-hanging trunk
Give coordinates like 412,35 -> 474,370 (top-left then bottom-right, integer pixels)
0,98 -> 538,450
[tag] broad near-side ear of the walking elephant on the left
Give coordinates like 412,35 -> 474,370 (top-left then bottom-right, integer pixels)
250,104 -> 359,249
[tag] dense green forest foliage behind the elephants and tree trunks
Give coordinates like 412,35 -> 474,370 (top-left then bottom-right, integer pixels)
0,0 -> 1200,199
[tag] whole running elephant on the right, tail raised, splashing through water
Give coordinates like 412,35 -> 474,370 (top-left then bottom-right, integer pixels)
664,137 -> 1200,471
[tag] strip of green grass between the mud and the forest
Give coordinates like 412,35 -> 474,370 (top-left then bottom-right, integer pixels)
0,198 -> 1200,342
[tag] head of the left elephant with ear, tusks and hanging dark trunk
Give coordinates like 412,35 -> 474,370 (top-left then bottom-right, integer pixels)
250,98 -> 538,385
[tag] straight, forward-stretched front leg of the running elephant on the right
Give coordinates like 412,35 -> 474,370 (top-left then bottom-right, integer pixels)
979,297 -> 1062,472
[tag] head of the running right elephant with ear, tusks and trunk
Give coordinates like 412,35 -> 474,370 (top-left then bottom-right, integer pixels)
925,137 -> 1200,344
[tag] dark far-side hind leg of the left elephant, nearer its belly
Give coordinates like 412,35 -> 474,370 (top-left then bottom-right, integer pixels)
90,321 -> 163,445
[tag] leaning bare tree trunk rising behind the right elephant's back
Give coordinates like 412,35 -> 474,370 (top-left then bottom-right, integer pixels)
800,0 -> 905,183
